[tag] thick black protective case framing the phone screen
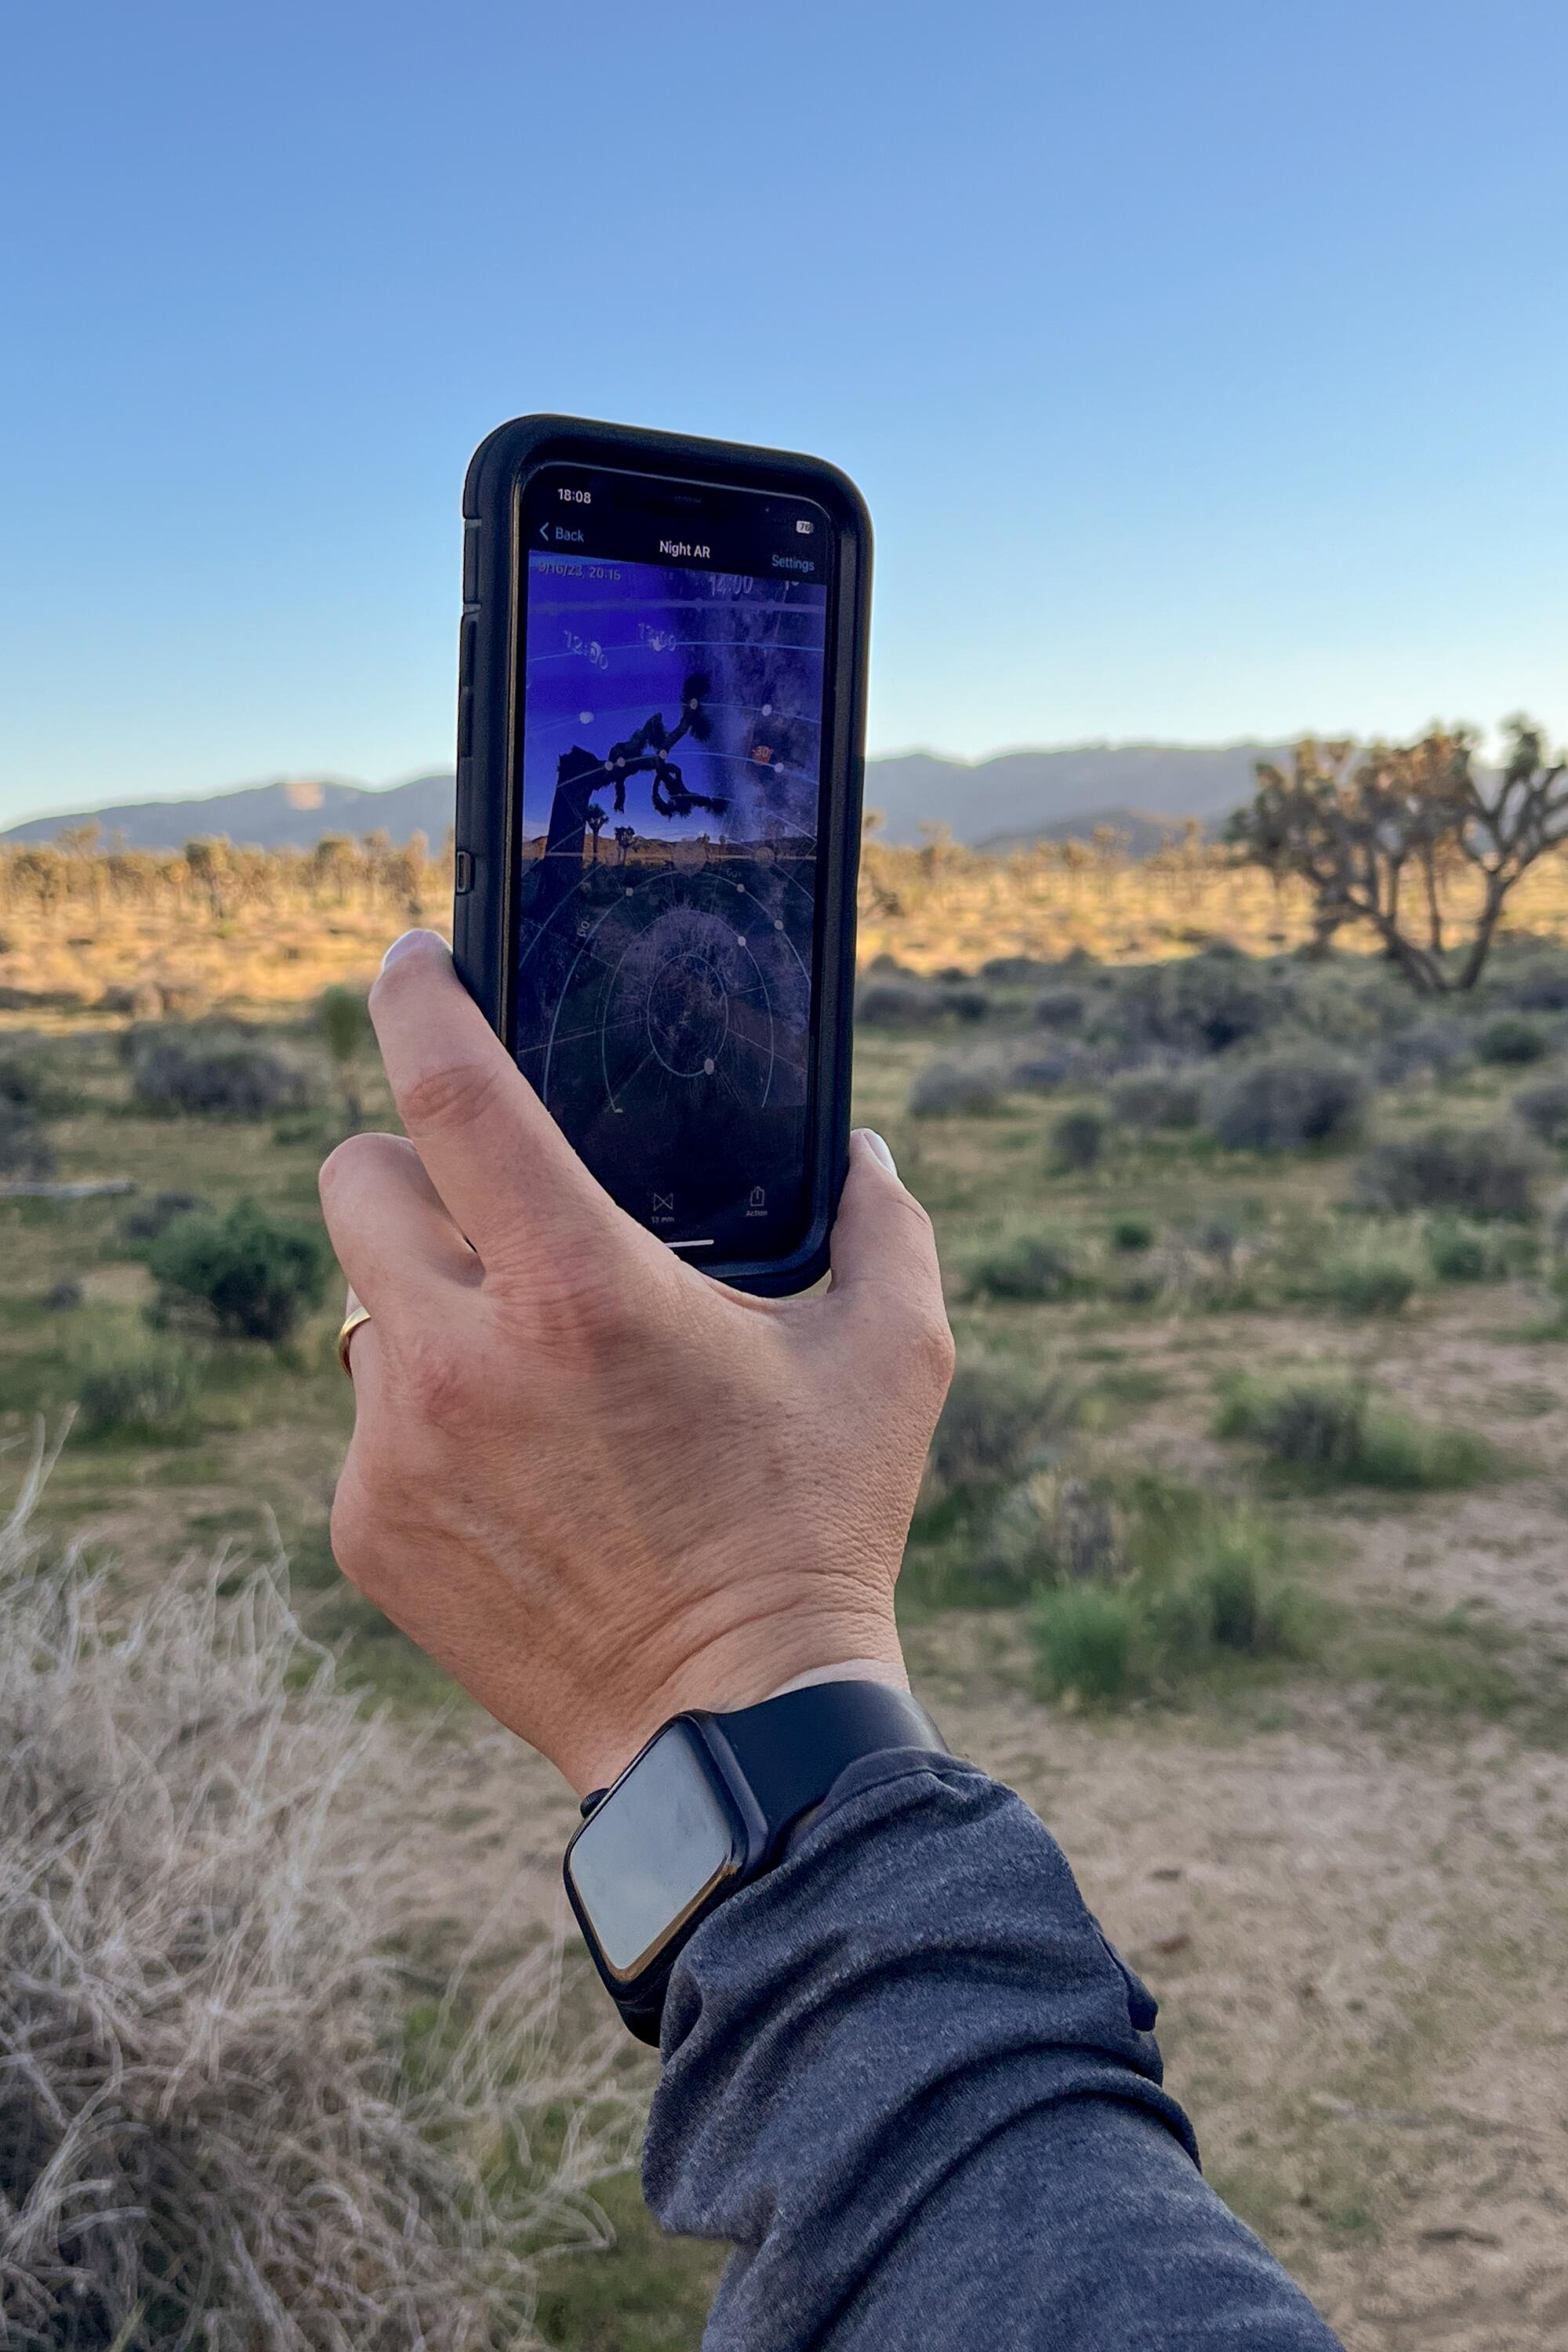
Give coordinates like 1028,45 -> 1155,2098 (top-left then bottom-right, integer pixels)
452,416 -> 872,1298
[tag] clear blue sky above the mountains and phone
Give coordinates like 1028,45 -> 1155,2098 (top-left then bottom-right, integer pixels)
0,0 -> 1568,818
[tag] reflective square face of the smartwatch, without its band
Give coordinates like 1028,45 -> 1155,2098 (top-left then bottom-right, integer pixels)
567,1722 -> 741,1983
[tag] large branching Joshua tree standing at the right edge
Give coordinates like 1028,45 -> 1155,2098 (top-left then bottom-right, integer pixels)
1227,717 -> 1568,995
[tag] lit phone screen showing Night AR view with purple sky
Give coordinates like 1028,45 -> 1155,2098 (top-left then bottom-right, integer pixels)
513,466 -> 834,1263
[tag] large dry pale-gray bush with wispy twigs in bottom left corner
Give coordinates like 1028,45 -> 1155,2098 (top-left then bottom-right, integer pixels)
0,1430 -> 635,2352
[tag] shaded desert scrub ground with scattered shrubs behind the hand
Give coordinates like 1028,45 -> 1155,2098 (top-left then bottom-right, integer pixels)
0,924 -> 1568,2352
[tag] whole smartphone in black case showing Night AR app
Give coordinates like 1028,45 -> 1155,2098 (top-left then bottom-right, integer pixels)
454,416 -> 872,1294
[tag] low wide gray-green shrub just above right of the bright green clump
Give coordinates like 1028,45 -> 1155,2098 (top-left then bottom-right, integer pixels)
1215,1371 -> 1493,1489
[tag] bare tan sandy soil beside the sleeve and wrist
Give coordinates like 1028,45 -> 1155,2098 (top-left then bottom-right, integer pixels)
380,1294 -> 1568,2352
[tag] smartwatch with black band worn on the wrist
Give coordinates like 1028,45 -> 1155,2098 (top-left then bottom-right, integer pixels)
564,1682 -> 947,2044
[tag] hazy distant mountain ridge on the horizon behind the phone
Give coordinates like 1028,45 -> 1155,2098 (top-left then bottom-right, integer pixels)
0,741 -> 1288,849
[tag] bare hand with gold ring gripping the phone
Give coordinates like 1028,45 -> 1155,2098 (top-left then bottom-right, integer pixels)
322,931 -> 952,1792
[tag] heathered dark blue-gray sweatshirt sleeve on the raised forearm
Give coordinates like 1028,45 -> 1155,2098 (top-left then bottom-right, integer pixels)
644,1750 -> 1335,2352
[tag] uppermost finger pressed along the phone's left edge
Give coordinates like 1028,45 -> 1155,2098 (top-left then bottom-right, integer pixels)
369,931 -> 616,1265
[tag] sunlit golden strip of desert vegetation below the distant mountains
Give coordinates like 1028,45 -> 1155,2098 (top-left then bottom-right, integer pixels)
0,828 -> 1568,1018
